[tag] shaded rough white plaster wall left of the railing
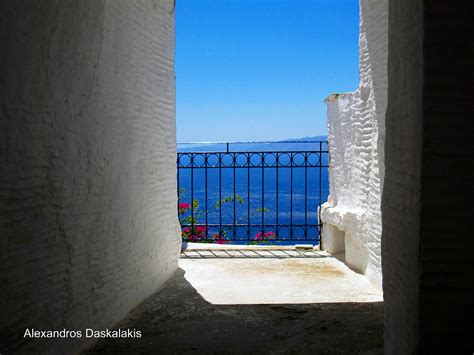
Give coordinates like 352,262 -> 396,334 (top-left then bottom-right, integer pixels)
0,0 -> 180,354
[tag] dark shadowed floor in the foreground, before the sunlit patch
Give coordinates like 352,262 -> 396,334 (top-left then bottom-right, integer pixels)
86,269 -> 383,354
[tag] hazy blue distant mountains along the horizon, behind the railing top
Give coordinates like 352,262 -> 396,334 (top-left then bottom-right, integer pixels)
178,136 -> 327,152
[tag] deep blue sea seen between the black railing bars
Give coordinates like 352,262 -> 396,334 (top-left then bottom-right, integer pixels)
178,139 -> 329,245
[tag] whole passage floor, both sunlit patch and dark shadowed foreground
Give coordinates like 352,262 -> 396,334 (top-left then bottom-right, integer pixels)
88,249 -> 383,354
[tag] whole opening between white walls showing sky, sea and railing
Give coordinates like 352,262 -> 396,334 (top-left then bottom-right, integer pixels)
176,1 -> 358,248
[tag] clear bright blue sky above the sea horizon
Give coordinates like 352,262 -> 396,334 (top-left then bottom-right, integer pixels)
176,0 -> 359,142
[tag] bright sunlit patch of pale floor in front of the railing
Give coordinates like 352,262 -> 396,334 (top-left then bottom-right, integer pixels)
179,253 -> 382,304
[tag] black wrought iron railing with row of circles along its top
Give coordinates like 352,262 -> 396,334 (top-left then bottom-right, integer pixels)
177,141 -> 329,244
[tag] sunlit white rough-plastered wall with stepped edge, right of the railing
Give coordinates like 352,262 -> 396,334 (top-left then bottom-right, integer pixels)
321,0 -> 388,288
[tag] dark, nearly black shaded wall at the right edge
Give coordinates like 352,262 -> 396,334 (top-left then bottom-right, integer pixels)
382,0 -> 474,354
